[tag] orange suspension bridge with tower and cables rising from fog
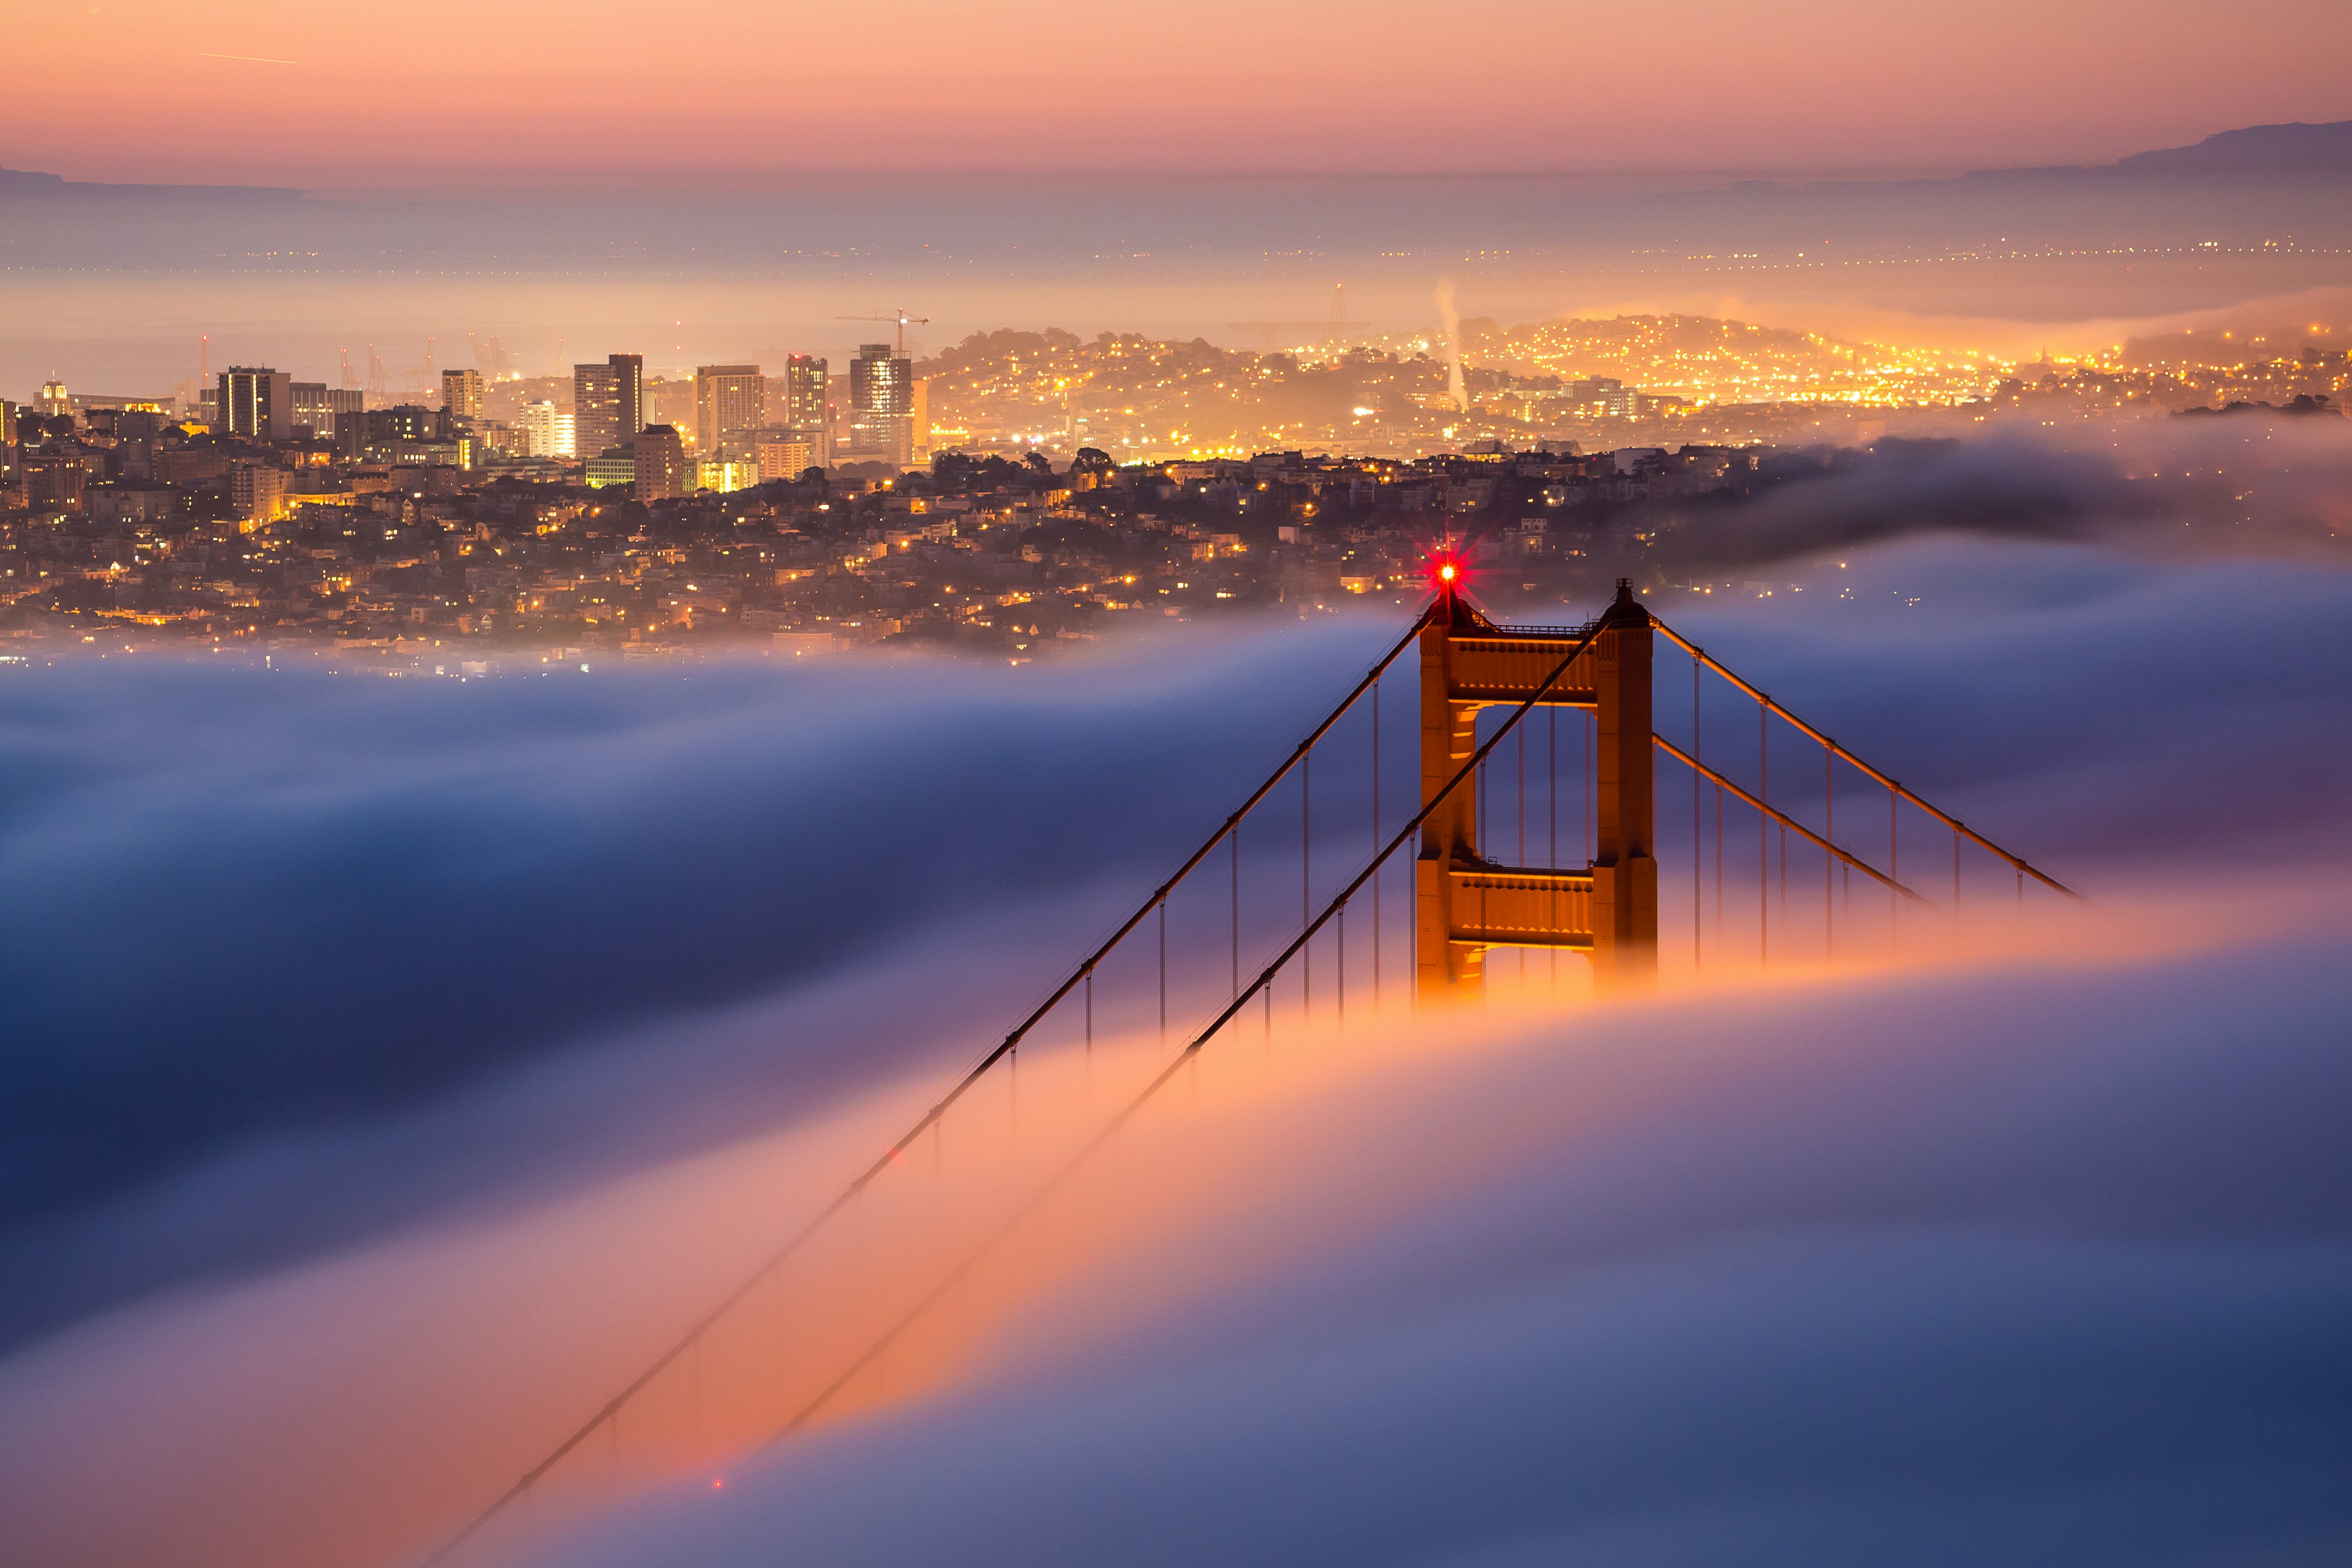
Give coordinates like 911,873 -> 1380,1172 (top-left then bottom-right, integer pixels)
423,571 -> 2079,1566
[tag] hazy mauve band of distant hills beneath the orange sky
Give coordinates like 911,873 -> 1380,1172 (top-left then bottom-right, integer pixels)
0,123 -> 2352,275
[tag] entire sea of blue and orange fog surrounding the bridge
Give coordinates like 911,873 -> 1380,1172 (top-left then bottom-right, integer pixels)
0,432 -> 2352,1568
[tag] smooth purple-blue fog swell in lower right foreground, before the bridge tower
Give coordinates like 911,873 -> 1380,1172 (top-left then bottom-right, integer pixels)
534,940 -> 2352,1568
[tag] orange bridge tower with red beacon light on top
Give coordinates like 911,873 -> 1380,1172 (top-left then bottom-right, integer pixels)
1414,578 -> 1658,1001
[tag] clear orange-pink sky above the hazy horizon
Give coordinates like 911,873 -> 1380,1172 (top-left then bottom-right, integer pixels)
13,0 -> 2352,190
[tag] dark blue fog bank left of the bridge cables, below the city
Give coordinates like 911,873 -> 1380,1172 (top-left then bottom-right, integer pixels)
0,628 -> 1385,1338
